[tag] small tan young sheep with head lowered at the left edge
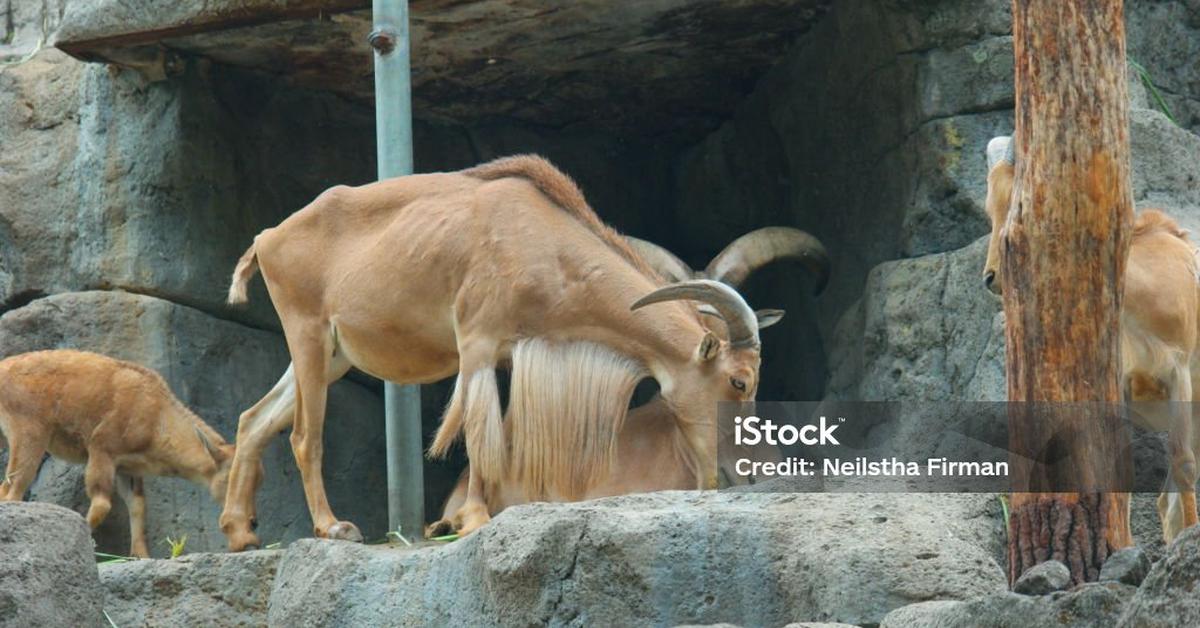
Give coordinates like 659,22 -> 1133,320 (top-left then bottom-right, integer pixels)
0,351 -> 260,557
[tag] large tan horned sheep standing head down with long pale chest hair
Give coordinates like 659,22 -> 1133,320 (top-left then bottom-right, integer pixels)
221,155 -> 806,550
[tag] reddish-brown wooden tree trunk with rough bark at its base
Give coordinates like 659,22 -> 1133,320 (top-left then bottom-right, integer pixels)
1002,0 -> 1133,590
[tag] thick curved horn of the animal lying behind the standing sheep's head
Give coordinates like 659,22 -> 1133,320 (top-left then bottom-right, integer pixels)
704,227 -> 829,294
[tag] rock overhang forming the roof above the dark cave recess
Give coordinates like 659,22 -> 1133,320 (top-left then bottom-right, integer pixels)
54,0 -> 832,136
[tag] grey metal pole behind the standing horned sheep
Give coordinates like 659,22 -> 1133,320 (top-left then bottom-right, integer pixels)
370,0 -> 425,538
